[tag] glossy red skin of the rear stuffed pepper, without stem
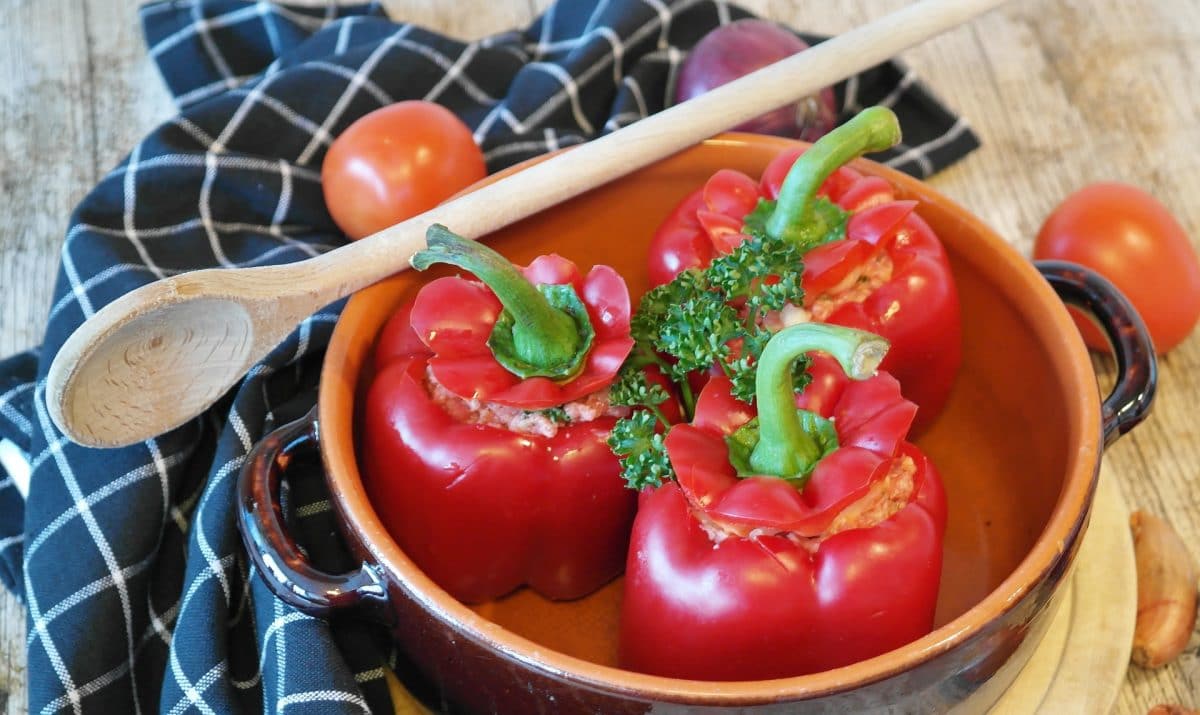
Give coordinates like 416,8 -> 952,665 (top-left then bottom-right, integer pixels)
648,149 -> 962,432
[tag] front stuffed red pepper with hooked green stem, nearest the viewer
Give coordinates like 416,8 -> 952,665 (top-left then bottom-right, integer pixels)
620,324 -> 946,680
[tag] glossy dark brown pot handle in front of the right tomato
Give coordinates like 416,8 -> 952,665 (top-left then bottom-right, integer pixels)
1033,260 -> 1158,447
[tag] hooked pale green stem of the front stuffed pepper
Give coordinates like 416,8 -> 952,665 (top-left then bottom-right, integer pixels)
750,323 -> 888,477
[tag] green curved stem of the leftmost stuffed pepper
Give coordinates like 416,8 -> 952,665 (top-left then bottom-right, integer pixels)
409,223 -> 583,368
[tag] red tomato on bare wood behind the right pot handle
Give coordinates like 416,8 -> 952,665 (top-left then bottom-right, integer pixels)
1033,182 -> 1200,354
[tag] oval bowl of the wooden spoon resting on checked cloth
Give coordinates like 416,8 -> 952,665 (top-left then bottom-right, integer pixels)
47,266 -> 296,446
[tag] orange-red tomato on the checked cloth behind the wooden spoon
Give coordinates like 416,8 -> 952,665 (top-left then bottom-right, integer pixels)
320,100 -> 487,239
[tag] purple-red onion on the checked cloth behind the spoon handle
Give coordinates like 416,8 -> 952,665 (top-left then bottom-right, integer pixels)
674,18 -> 838,142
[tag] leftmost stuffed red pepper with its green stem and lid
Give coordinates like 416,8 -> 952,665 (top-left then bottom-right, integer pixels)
361,227 -> 636,602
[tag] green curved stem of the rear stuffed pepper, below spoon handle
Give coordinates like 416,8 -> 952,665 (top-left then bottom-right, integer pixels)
766,107 -> 900,240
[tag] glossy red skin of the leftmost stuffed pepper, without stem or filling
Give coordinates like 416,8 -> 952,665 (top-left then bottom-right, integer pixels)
361,245 -> 636,602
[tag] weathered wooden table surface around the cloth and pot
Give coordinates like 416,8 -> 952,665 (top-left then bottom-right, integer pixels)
0,0 -> 1200,714
